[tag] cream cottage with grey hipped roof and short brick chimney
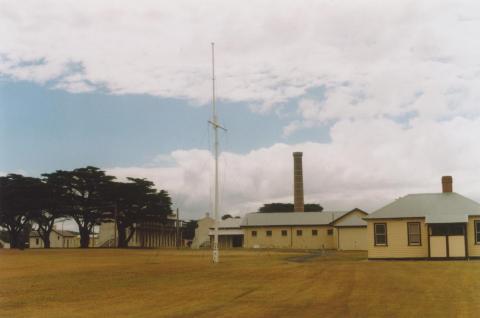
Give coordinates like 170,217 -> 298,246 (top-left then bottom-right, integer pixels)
364,176 -> 480,259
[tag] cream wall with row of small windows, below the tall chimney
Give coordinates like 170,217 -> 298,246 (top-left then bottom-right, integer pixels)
244,226 -> 336,249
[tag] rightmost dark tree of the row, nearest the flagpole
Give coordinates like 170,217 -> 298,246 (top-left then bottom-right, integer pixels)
103,178 -> 172,247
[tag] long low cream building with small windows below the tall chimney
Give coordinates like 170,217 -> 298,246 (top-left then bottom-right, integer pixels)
241,208 -> 367,250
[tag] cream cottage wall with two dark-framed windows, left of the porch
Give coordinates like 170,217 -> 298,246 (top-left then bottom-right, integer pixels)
367,219 -> 428,258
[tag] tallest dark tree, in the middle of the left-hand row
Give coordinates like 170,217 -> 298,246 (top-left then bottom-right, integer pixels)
44,166 -> 115,248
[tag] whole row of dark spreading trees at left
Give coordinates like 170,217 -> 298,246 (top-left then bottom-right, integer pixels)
0,166 -> 176,248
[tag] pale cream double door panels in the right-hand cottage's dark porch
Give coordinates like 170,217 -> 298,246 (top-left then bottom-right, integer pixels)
429,223 -> 467,258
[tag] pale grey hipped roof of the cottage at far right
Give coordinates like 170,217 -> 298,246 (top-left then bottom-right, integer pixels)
364,192 -> 480,223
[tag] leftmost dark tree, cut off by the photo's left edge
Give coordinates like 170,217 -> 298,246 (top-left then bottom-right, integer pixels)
0,174 -> 44,249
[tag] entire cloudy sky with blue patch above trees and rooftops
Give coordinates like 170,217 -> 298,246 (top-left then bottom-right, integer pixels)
0,0 -> 480,218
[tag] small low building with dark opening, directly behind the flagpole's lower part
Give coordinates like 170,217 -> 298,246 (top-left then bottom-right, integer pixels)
209,218 -> 244,248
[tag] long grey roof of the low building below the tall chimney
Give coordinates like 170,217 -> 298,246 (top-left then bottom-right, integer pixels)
241,211 -> 349,227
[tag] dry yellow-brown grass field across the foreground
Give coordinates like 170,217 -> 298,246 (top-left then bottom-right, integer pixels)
0,249 -> 480,318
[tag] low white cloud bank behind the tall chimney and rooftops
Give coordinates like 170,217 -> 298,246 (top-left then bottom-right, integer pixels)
107,118 -> 480,217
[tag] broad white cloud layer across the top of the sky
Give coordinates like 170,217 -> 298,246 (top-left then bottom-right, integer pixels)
0,0 -> 480,120
